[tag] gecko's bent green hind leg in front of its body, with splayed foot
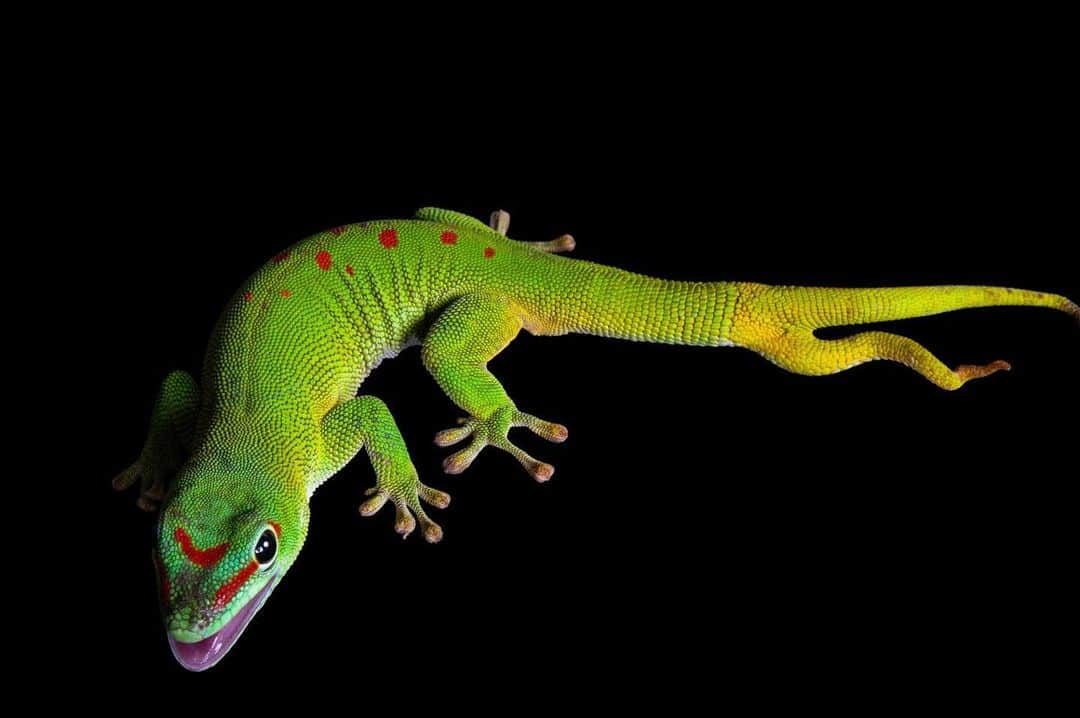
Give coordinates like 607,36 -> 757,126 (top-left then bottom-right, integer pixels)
422,294 -> 567,482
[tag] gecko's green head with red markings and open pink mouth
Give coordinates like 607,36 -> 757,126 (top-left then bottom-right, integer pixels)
153,470 -> 308,670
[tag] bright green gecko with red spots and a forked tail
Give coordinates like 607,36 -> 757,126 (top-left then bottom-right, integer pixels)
113,208 -> 1080,670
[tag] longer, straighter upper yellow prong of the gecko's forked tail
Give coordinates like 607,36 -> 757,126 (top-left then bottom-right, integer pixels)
761,285 -> 1080,329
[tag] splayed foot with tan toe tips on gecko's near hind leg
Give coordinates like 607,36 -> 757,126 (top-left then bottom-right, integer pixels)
435,406 -> 567,482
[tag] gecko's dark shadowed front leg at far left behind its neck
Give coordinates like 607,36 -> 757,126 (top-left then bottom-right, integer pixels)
112,371 -> 199,511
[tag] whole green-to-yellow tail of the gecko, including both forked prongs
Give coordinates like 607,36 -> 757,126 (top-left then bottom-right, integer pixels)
530,260 -> 1080,389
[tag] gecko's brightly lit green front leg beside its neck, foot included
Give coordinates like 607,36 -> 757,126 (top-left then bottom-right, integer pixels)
322,396 -> 450,543
